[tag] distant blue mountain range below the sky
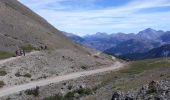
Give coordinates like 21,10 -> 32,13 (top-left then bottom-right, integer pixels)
63,28 -> 170,59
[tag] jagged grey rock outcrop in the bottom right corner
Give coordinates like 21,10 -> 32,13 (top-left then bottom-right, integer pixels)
112,81 -> 170,100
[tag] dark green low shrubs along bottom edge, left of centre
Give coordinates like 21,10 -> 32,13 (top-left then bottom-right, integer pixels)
44,88 -> 93,100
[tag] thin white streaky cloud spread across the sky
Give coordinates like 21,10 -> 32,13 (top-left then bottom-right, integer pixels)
19,0 -> 170,35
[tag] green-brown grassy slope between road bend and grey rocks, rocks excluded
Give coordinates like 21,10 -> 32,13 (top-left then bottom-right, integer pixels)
94,59 -> 170,91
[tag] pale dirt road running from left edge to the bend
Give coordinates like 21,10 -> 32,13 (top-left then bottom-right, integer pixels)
0,62 -> 123,97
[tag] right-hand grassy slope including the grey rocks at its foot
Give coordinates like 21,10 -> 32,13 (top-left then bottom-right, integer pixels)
82,58 -> 170,100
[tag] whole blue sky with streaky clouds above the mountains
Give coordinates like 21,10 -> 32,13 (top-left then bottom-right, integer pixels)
20,0 -> 170,35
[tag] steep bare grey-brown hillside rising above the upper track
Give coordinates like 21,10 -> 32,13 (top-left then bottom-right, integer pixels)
0,0 -> 77,52
